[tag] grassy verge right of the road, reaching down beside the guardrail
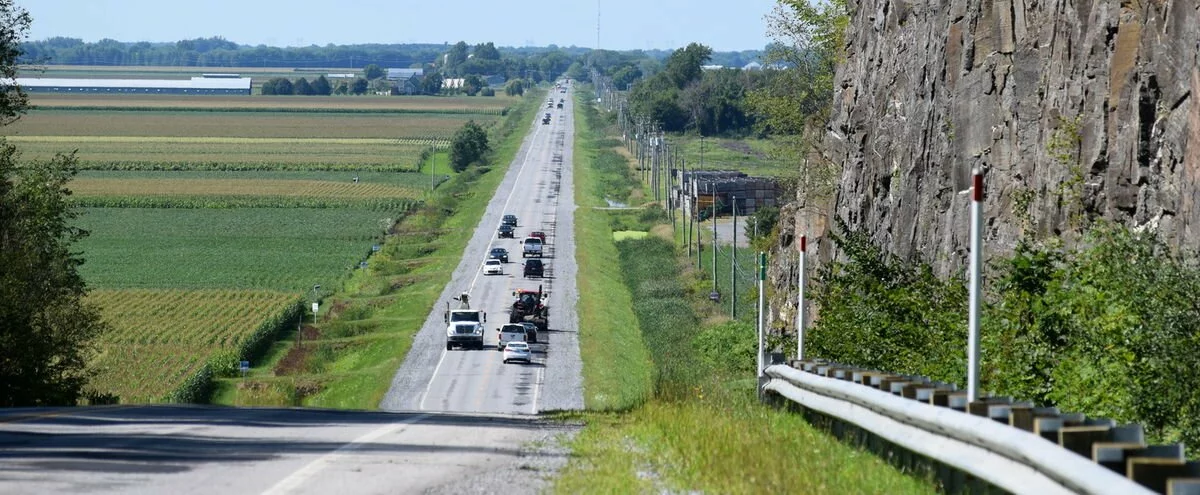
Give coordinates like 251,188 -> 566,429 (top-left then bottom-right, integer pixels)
554,93 -> 934,494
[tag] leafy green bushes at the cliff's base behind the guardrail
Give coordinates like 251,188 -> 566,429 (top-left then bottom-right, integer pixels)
808,225 -> 1200,456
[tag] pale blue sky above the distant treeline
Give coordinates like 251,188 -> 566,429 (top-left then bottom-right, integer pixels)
25,0 -> 775,52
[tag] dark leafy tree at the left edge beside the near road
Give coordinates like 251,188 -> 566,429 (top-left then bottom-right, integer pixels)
0,0 -> 107,407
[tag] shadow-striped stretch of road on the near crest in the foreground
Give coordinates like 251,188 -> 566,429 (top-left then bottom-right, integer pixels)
0,406 -> 569,495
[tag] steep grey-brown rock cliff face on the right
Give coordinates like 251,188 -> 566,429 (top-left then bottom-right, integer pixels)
775,0 -> 1200,329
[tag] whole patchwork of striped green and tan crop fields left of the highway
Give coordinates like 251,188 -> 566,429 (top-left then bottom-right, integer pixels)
22,84 -> 516,402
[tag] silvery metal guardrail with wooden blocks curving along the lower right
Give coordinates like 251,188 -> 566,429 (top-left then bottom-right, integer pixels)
762,360 -> 1200,495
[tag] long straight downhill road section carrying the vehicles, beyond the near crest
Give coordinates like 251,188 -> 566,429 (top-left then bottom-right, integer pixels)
379,85 -> 583,415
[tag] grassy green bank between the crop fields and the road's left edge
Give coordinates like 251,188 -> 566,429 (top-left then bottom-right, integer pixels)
214,94 -> 541,408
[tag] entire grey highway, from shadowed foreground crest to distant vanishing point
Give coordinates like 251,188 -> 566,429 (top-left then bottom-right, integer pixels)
0,87 -> 583,495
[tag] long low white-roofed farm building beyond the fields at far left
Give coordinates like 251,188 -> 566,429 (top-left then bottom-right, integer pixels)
0,74 -> 251,95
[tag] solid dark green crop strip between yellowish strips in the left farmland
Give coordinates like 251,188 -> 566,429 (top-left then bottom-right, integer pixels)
77,208 -> 395,292
